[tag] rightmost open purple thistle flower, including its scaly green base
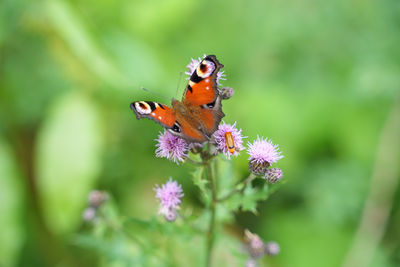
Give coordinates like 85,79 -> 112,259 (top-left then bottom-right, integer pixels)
247,136 -> 283,175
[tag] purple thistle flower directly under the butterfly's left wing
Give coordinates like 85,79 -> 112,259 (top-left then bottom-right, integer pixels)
156,130 -> 189,164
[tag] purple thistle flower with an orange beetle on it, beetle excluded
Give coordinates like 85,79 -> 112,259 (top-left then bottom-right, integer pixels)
212,122 -> 245,159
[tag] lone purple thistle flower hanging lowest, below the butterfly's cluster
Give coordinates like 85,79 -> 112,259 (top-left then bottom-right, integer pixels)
154,178 -> 183,221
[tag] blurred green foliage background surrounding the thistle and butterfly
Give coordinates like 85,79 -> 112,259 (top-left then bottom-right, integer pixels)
0,0 -> 400,267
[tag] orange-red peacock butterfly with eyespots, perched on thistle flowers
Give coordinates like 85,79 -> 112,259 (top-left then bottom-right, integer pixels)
130,55 -> 225,143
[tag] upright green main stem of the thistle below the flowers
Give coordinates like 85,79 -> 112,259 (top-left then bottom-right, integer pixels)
205,160 -> 217,266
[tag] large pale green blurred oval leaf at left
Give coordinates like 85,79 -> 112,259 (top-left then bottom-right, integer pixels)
37,93 -> 102,233
